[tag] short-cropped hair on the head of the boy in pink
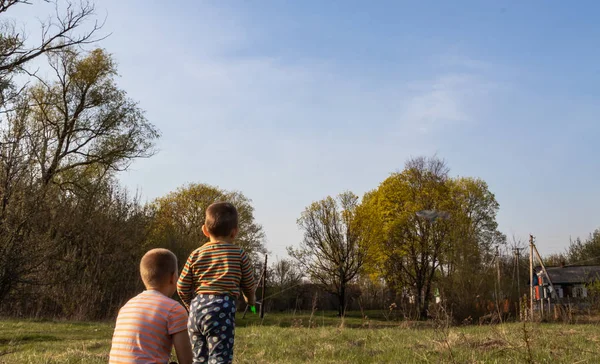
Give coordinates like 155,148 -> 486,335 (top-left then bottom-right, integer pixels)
140,248 -> 177,288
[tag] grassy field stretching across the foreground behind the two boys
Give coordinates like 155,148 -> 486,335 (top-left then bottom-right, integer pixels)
0,313 -> 600,364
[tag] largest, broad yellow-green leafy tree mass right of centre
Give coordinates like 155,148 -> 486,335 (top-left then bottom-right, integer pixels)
358,157 -> 504,318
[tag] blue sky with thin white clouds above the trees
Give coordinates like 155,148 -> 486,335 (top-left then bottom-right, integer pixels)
9,0 -> 600,257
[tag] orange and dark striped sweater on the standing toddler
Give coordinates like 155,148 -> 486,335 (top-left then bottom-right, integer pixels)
177,242 -> 255,309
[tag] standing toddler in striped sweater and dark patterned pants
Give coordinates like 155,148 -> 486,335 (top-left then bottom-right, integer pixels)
177,202 -> 256,364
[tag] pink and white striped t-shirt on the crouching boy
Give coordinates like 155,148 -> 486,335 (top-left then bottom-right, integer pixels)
109,290 -> 188,364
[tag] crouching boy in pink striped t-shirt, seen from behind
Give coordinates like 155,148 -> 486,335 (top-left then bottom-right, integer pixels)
109,249 -> 192,364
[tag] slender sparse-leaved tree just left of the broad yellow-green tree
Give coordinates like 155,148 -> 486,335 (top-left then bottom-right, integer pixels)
288,192 -> 366,316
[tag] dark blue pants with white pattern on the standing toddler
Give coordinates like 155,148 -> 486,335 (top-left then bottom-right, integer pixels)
188,294 -> 235,364
